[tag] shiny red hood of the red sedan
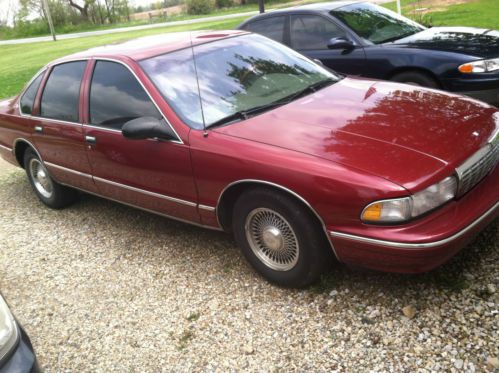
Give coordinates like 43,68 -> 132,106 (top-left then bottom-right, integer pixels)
215,78 -> 499,190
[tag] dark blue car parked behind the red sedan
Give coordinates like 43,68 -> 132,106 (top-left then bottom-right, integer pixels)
238,1 -> 499,105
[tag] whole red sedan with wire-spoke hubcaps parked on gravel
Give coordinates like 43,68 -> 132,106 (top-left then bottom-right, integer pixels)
0,31 -> 499,286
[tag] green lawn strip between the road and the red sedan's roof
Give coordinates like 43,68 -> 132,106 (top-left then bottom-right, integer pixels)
0,17 -> 245,98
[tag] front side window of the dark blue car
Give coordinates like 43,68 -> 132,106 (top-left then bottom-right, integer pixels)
291,15 -> 345,50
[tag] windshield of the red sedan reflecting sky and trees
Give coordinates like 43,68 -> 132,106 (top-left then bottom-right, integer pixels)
140,34 -> 340,129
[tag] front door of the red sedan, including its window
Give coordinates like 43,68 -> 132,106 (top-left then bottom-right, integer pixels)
84,60 -> 199,222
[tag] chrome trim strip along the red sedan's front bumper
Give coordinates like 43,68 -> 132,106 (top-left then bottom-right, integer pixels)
329,202 -> 499,249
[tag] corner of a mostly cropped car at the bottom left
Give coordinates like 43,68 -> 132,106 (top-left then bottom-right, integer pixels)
0,295 -> 39,373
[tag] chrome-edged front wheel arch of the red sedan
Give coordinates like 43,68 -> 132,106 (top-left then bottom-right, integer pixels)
215,179 -> 339,260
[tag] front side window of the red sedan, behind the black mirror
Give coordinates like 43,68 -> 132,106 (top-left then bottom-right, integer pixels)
89,61 -> 162,129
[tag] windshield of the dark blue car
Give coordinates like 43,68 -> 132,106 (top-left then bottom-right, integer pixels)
331,3 -> 425,44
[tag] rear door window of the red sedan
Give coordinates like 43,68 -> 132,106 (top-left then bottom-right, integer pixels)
40,61 -> 87,122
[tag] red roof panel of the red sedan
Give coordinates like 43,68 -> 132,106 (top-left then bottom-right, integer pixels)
51,30 -> 247,64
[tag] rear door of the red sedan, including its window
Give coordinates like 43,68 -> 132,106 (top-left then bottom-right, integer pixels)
31,60 -> 95,191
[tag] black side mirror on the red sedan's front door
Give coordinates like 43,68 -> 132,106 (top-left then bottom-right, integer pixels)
121,117 -> 176,140
